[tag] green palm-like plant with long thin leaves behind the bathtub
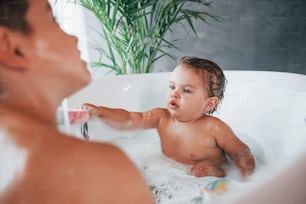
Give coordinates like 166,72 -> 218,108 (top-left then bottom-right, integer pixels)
78,0 -> 220,74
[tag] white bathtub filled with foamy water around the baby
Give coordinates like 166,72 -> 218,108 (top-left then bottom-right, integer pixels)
61,71 -> 306,204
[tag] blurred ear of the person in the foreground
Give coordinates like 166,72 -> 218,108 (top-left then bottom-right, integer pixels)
0,26 -> 30,69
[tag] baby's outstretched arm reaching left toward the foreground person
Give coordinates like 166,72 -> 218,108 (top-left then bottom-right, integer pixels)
71,103 -> 162,130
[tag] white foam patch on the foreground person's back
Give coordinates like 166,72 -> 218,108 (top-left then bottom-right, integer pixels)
0,131 -> 27,194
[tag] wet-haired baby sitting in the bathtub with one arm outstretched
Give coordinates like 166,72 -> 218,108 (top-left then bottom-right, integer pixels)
69,57 -> 255,177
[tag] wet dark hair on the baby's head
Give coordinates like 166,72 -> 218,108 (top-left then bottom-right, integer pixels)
179,56 -> 226,114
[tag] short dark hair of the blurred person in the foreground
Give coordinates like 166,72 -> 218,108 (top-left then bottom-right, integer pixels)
0,0 -> 31,34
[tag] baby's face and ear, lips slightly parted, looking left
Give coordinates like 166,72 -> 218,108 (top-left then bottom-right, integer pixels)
167,64 -> 218,121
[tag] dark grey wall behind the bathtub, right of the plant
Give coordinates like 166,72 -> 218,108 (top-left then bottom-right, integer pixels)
154,0 -> 306,74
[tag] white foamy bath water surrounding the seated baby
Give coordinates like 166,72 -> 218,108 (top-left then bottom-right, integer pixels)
109,130 -> 270,204
